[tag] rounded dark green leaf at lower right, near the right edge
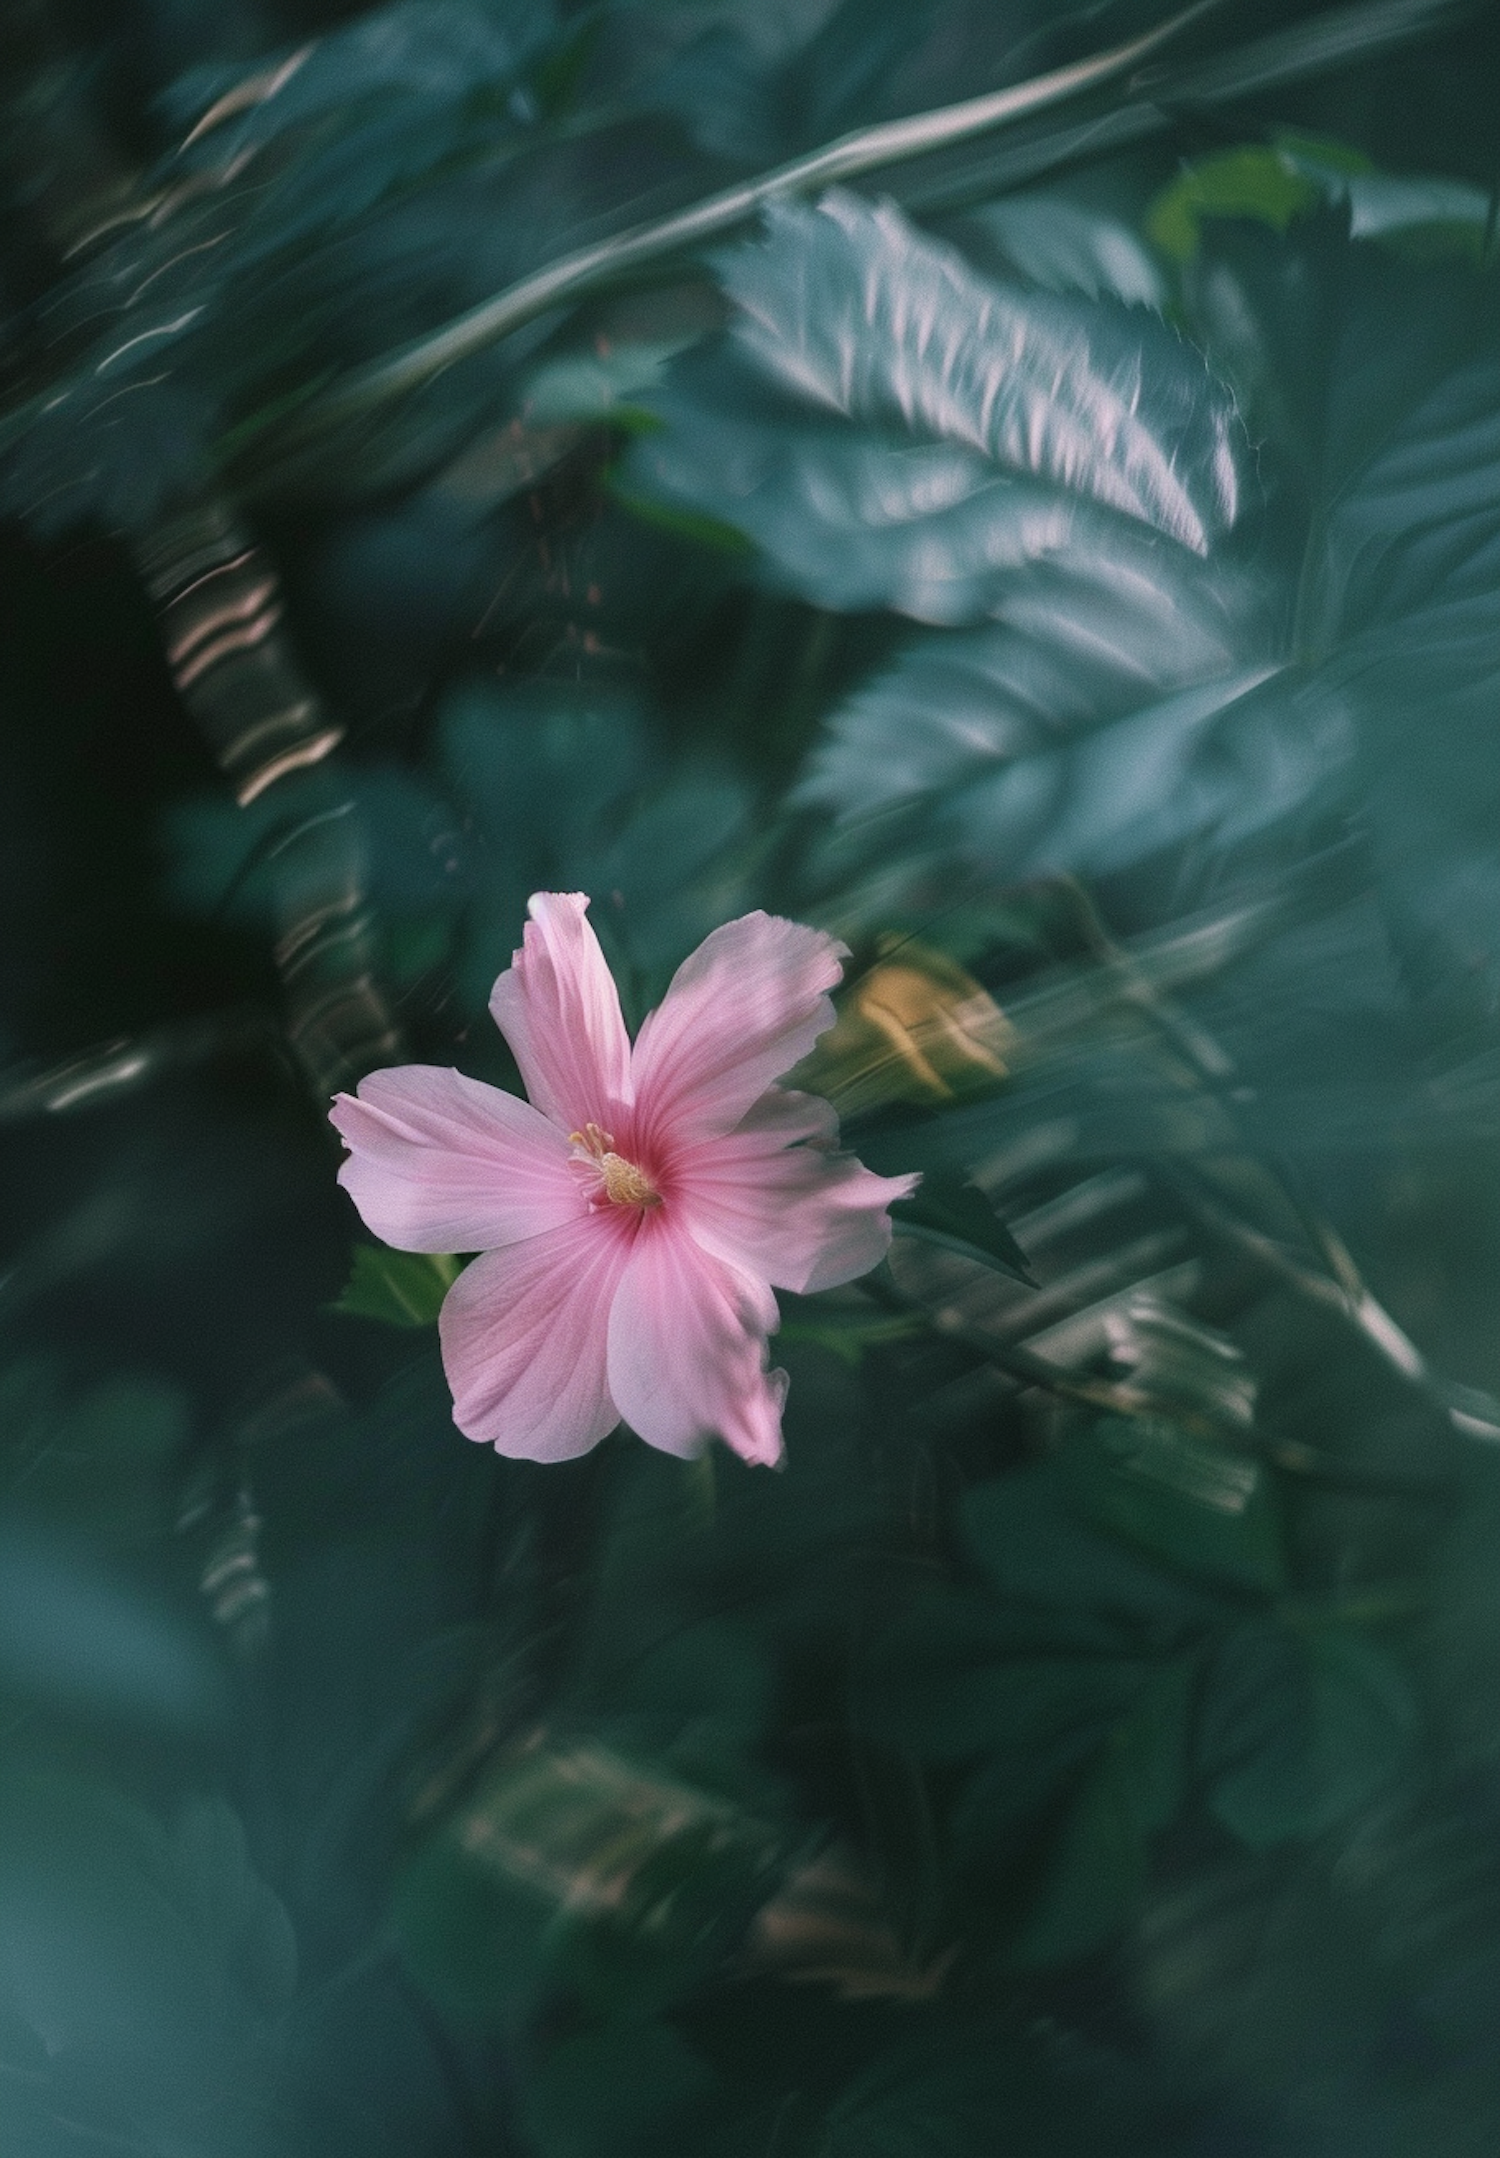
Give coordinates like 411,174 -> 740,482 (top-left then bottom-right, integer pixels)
1198,1619 -> 1418,1849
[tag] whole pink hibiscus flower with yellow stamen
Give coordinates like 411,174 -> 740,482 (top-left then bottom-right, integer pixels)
332,891 -> 917,1463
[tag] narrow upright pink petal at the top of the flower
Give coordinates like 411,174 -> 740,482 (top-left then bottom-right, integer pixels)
490,891 -> 630,1131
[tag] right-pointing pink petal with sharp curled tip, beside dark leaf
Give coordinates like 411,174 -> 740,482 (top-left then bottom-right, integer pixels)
671,1088 -> 917,1295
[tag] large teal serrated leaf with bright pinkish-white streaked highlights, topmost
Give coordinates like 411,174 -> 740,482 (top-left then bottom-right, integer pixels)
626,194 -> 1239,624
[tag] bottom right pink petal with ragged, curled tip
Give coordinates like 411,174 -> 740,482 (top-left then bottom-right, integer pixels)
609,1219 -> 786,1465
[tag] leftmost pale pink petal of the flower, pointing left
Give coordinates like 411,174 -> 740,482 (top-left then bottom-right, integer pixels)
328,1064 -> 587,1252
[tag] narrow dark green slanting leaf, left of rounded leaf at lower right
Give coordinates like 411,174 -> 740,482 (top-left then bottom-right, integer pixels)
1012,1657 -> 1200,1964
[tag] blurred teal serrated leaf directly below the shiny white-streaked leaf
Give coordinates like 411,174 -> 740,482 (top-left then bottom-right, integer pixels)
799,625 -> 1312,878
